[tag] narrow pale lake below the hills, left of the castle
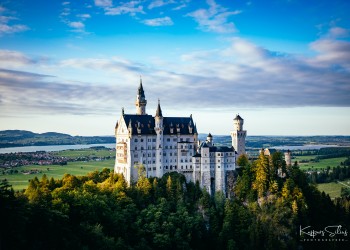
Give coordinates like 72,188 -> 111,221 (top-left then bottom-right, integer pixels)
0,143 -> 115,154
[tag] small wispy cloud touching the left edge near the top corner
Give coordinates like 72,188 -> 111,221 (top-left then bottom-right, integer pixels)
0,6 -> 29,36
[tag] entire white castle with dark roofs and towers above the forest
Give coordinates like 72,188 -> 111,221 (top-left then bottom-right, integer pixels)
114,80 -> 247,194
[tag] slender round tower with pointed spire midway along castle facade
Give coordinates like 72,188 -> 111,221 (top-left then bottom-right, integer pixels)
154,99 -> 164,178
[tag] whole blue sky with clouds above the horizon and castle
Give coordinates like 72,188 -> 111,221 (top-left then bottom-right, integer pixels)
0,0 -> 350,136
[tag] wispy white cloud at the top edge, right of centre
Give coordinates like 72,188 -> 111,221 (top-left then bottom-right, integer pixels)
187,0 -> 241,33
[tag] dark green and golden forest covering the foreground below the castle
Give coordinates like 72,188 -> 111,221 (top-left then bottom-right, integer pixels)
0,152 -> 350,250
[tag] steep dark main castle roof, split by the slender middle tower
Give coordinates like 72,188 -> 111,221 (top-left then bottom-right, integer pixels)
123,114 -> 197,135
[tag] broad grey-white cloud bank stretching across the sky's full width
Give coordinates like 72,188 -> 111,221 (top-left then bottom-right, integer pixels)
0,26 -> 350,117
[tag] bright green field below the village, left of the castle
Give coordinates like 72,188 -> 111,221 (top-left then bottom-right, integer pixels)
0,158 -> 114,190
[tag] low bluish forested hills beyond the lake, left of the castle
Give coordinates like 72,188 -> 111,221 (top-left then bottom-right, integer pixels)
0,130 -> 115,148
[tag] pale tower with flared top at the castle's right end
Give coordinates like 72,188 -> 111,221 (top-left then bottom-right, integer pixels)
231,115 -> 247,156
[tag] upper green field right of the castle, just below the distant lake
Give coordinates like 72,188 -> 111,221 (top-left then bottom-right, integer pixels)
292,155 -> 347,170
